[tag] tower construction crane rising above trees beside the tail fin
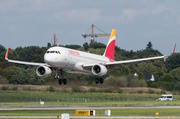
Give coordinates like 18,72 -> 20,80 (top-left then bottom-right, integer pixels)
82,24 -> 110,42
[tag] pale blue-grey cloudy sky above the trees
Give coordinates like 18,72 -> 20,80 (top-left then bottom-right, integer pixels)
0,0 -> 180,55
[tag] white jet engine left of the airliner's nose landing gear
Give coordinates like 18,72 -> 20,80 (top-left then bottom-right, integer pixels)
36,66 -> 52,78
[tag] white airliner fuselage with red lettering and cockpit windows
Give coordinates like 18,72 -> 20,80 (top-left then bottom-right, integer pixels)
44,47 -> 110,74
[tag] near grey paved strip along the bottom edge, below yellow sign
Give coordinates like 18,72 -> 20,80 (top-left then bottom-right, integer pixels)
0,116 -> 180,119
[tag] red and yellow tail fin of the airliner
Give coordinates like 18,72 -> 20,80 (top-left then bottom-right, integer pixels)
103,29 -> 116,60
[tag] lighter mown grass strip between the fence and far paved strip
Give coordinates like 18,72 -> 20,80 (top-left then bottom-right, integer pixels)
0,101 -> 180,107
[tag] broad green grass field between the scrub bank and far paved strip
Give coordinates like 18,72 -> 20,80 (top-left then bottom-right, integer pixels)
0,91 -> 180,107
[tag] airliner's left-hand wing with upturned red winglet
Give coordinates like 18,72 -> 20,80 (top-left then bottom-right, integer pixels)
5,48 -> 48,66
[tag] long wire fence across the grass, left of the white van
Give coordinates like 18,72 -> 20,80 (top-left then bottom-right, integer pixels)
0,95 -> 180,102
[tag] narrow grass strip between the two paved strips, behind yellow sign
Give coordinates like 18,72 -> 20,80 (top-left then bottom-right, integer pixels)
0,108 -> 180,116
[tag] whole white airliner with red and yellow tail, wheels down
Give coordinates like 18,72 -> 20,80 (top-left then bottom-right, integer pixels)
5,29 -> 175,85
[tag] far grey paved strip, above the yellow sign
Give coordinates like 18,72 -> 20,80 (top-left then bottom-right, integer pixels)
0,105 -> 180,110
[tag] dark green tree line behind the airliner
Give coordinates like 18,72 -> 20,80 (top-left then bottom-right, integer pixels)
0,42 -> 180,90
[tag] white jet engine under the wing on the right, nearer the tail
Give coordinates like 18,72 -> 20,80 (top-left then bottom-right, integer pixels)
92,64 -> 107,76
